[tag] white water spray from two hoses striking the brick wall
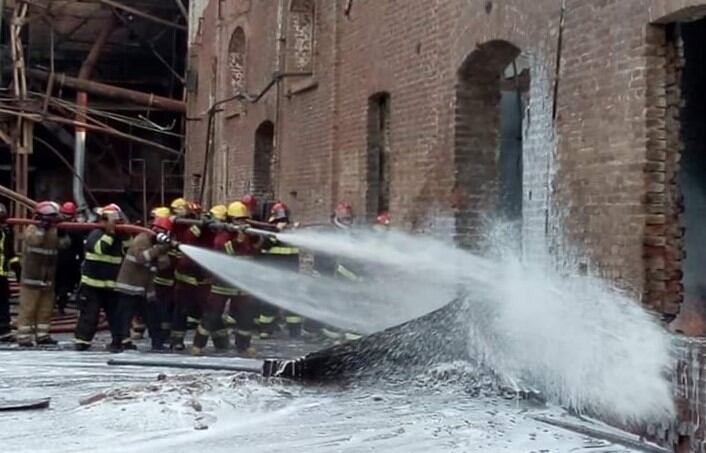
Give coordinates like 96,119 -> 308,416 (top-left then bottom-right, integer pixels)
179,226 -> 674,422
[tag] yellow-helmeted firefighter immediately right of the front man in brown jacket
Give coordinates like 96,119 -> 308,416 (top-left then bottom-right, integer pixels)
170,200 -> 210,351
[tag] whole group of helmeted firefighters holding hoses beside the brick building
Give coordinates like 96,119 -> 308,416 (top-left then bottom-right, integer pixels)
0,195 -> 390,356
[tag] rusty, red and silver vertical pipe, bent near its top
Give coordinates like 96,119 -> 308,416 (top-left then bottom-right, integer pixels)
73,16 -> 115,212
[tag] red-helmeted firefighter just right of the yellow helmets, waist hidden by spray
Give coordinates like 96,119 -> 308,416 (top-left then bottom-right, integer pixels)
258,201 -> 303,338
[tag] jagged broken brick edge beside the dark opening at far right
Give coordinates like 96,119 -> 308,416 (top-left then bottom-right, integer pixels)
643,27 -> 683,320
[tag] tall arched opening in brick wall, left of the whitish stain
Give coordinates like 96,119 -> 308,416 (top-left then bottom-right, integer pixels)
454,41 -> 529,250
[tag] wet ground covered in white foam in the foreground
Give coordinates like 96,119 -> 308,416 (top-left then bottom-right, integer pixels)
0,332 -> 656,453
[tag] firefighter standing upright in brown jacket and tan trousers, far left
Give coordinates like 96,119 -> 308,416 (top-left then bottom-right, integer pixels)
17,201 -> 69,346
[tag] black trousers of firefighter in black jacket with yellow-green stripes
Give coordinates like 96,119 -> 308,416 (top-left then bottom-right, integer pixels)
74,286 -> 124,344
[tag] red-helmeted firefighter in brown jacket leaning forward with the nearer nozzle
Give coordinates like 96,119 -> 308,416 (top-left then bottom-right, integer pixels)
115,217 -> 172,351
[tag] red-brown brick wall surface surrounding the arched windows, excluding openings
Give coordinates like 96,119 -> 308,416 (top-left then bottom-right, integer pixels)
186,0 -> 702,304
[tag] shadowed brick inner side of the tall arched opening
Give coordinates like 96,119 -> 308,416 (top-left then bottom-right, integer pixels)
453,40 -> 522,248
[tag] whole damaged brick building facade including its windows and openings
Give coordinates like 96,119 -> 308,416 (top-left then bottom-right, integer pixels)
185,0 -> 706,444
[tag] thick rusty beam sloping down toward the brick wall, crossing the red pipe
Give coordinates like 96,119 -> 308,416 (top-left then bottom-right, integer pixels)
27,69 -> 186,113
